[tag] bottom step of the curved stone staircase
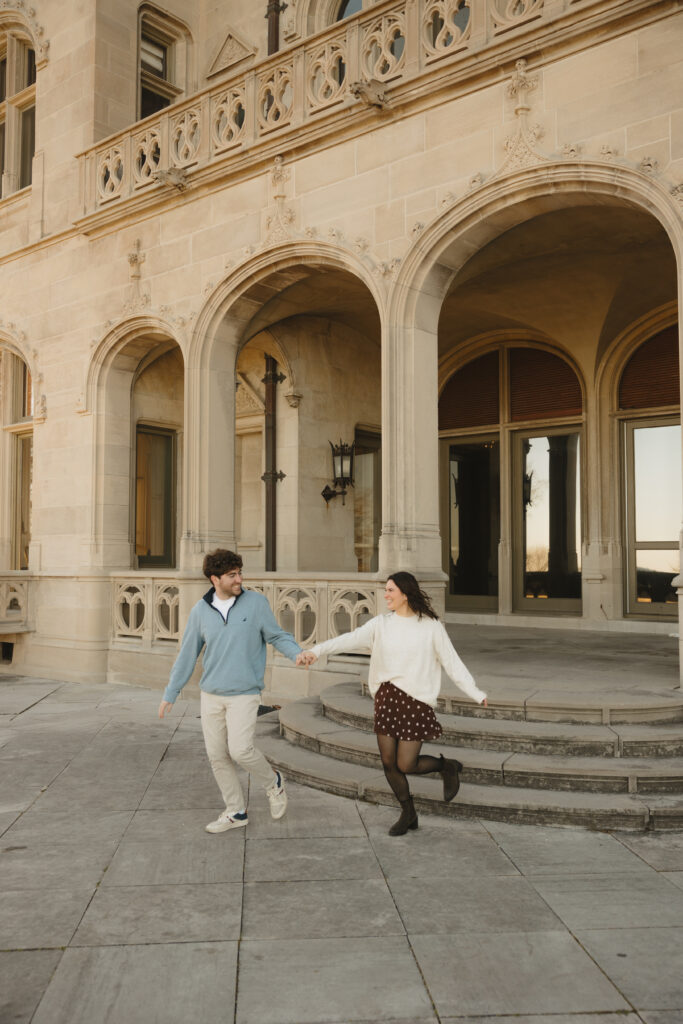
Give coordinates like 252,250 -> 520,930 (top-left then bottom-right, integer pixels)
258,712 -> 683,831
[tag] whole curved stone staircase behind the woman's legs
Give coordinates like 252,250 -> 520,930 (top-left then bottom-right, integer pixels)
259,680 -> 683,830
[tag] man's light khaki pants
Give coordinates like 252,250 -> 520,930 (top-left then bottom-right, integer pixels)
201,691 -> 275,812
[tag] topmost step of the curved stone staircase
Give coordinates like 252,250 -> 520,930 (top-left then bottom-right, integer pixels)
364,680 -> 683,725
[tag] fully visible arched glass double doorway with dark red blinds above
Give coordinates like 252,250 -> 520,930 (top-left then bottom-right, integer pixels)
438,346 -> 583,611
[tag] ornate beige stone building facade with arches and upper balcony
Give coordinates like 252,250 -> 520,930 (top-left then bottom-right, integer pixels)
0,0 -> 683,689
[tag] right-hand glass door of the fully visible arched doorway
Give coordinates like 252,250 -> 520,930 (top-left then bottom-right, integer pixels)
513,431 -> 581,613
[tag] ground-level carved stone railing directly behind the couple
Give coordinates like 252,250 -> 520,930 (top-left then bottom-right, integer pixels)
113,573 -> 377,647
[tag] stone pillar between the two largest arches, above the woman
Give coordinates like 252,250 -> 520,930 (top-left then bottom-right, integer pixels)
379,315 -> 445,590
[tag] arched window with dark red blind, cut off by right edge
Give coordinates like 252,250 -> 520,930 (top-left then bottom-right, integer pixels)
618,326 -> 681,618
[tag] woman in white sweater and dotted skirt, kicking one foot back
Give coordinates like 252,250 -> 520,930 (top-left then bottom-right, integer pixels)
297,572 -> 486,836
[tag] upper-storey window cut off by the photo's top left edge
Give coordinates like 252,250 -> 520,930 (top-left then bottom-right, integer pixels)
0,31 -> 36,198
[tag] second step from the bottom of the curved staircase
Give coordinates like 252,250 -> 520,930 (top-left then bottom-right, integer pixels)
280,697 -> 683,794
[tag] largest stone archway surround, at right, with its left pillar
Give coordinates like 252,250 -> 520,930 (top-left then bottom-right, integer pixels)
383,162 -> 683,605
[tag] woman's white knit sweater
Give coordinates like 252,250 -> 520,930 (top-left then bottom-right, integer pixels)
311,612 -> 486,708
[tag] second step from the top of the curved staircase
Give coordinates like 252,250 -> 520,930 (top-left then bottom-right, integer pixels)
333,681 -> 683,758
